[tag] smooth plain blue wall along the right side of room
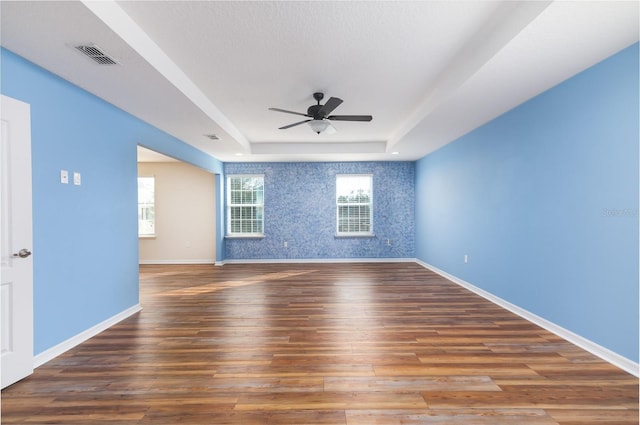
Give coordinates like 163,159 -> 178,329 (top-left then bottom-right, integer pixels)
416,44 -> 639,362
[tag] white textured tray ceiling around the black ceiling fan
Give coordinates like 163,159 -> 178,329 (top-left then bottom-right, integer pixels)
0,0 -> 638,161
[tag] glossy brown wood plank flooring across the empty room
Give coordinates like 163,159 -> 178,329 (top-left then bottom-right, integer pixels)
2,263 -> 639,425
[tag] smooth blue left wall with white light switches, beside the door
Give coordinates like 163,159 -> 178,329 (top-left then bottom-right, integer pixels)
1,49 -> 222,354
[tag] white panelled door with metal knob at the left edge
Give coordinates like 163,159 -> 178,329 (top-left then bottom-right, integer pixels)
0,96 -> 33,388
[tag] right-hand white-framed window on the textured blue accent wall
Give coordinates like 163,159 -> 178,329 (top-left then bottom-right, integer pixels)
336,174 -> 373,236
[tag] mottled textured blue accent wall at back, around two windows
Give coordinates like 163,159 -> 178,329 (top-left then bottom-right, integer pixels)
224,162 -> 415,260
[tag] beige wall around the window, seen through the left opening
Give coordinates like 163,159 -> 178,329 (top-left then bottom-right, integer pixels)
138,162 -> 216,264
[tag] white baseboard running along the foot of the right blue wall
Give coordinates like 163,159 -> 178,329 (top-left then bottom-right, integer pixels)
416,260 -> 640,376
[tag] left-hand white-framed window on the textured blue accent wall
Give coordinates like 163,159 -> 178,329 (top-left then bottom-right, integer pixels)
227,175 -> 264,236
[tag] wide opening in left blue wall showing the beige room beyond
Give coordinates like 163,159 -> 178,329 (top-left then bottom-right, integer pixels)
138,146 -> 218,294
